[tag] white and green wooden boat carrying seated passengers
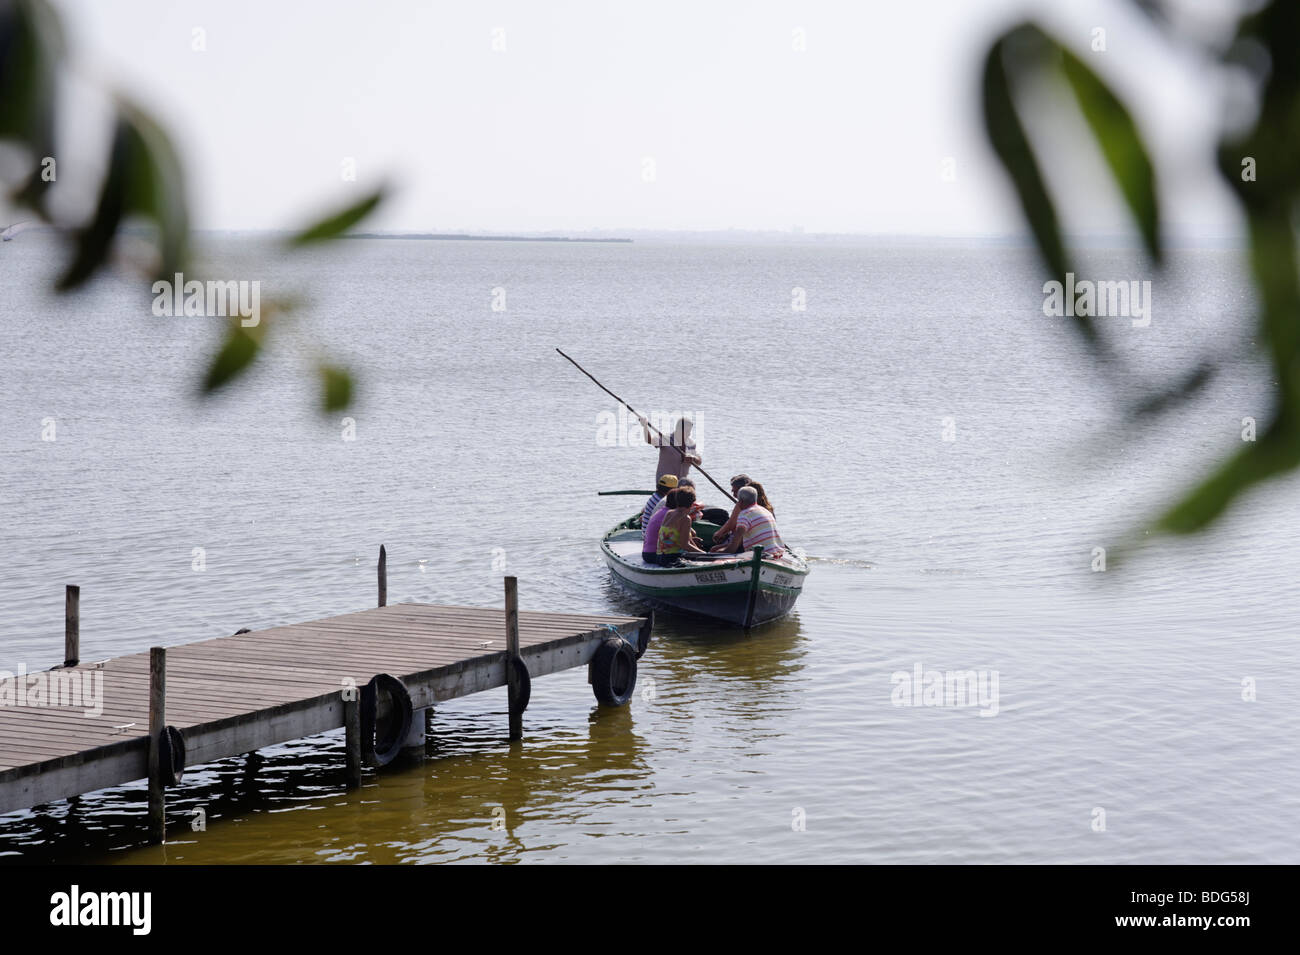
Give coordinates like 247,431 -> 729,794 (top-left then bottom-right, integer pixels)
601,513 -> 809,628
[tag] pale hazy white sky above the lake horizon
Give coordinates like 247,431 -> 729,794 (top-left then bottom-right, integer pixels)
40,0 -> 1234,234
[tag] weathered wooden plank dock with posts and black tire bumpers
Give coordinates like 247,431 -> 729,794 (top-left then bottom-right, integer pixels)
0,572 -> 653,839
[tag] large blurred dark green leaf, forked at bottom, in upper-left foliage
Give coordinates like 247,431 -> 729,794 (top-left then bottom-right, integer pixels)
59,103 -> 189,291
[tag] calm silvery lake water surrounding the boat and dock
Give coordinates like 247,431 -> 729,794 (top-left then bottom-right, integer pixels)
0,233 -> 1300,863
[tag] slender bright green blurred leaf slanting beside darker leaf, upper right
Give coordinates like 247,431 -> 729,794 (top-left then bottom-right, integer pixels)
1057,45 -> 1162,264
